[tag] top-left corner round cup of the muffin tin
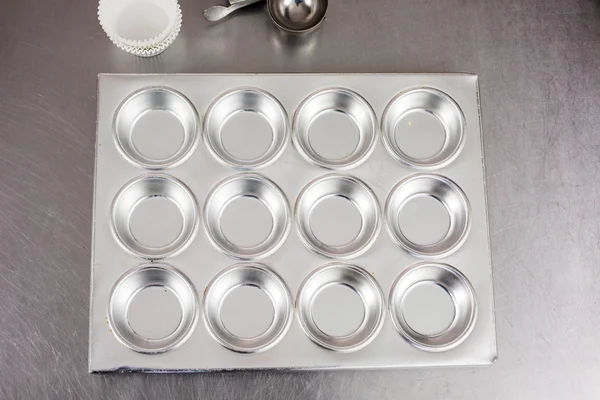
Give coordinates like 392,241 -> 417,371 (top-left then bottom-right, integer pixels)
114,87 -> 198,170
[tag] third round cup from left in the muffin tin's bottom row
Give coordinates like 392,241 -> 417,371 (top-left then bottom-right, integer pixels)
296,263 -> 385,352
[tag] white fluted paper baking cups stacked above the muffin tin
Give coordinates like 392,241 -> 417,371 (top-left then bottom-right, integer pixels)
98,0 -> 181,56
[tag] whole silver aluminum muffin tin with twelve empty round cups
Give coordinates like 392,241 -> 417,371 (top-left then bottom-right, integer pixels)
89,74 -> 496,372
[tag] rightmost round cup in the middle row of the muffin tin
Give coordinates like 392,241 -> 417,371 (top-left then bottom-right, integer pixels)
385,174 -> 471,257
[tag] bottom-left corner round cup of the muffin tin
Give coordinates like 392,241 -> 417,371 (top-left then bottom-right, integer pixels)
108,263 -> 197,354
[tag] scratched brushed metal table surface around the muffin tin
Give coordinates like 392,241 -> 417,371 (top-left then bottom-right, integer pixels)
0,0 -> 600,399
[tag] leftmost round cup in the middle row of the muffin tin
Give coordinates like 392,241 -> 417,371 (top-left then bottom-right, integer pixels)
111,174 -> 198,259
